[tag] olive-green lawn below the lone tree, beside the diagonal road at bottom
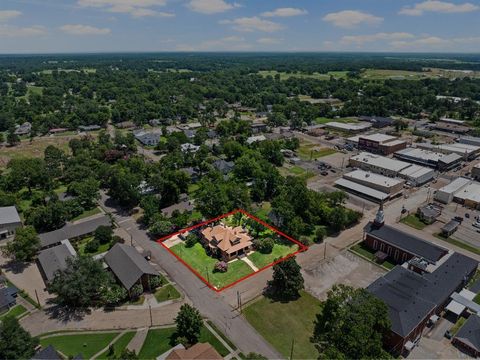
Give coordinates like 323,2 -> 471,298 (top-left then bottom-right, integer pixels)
244,291 -> 320,359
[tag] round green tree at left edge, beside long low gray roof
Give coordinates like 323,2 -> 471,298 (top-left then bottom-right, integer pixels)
3,226 -> 40,262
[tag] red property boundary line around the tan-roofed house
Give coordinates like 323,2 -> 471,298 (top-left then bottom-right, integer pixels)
157,209 -> 308,292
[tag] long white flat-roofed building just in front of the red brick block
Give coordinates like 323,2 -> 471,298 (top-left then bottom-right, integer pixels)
349,152 -> 435,186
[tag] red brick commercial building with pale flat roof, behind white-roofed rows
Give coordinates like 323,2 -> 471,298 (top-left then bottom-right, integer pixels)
347,133 -> 407,155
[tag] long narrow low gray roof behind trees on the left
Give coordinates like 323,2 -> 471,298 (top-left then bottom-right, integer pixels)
38,215 -> 112,247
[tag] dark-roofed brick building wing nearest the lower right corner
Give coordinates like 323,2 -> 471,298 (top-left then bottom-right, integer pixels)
367,253 -> 478,354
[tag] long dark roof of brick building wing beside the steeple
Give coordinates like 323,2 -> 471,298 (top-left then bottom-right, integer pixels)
365,222 -> 447,263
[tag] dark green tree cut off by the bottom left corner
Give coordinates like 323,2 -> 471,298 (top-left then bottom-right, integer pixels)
0,316 -> 39,359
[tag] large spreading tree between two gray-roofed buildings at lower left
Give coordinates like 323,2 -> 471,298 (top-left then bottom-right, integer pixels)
48,256 -> 114,308
